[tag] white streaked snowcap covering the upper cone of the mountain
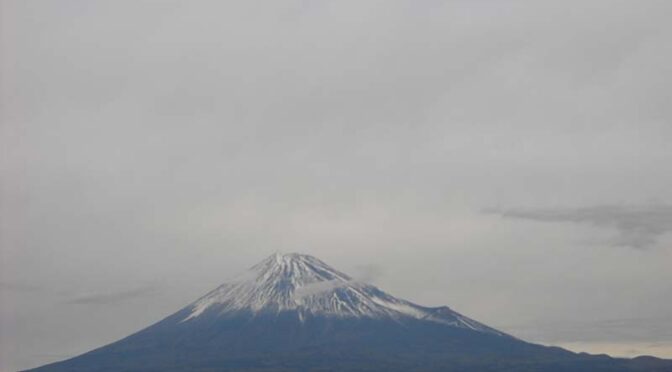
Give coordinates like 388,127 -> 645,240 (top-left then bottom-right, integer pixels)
182,253 -> 504,335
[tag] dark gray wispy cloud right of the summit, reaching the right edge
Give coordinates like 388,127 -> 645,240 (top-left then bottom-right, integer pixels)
486,204 -> 672,249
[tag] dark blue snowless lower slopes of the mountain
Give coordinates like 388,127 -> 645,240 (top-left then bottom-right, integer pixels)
25,312 -> 672,372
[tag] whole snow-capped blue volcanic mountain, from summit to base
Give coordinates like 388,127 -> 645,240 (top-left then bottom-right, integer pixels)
26,254 -> 672,372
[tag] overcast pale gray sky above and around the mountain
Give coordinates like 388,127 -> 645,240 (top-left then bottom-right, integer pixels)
0,0 -> 672,372
